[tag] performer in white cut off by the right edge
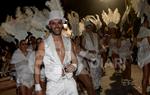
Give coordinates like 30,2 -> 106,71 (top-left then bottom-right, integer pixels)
137,17 -> 150,95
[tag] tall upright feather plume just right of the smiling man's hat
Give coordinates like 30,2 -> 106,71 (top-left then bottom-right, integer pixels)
67,11 -> 80,36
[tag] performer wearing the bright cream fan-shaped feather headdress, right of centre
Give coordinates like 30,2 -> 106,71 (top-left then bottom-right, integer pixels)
102,8 -> 121,75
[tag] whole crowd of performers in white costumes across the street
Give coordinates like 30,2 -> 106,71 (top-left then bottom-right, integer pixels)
0,0 -> 150,95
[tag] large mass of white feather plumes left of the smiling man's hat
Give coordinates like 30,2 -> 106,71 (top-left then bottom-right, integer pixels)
2,7 -> 47,41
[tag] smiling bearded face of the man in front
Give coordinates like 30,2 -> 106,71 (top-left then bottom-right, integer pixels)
49,19 -> 63,35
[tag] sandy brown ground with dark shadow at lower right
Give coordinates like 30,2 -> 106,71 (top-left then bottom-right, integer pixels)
100,64 -> 142,95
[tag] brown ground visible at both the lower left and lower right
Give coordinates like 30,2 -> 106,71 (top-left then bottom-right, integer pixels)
0,64 -> 142,95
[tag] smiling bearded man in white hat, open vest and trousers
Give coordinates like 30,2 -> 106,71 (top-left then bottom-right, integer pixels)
35,10 -> 78,95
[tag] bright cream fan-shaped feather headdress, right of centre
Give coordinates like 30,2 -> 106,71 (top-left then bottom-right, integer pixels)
101,8 -> 121,26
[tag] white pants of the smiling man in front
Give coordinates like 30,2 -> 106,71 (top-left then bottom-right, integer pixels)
46,78 -> 78,95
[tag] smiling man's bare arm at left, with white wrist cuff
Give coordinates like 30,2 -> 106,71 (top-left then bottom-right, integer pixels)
34,42 -> 45,91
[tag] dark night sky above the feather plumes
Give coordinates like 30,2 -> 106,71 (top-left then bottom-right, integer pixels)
0,0 -> 125,23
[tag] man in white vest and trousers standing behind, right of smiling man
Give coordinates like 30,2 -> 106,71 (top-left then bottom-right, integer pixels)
81,21 -> 101,93
